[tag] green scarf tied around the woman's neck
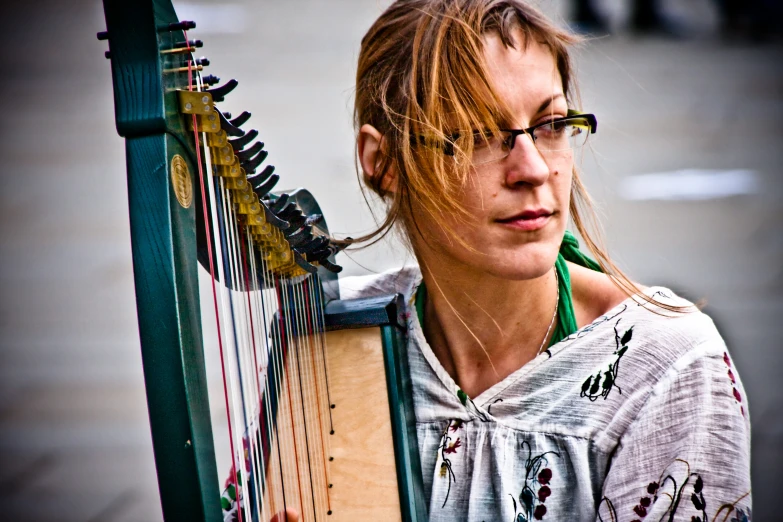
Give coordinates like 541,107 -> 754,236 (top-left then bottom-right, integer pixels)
416,230 -> 602,346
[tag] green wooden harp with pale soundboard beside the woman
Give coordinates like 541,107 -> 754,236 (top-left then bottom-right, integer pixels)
98,0 -> 426,522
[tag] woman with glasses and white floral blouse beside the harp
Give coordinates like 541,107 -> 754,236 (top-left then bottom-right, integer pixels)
266,0 -> 751,522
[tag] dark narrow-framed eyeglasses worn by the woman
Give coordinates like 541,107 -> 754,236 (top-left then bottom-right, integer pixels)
443,111 -> 598,165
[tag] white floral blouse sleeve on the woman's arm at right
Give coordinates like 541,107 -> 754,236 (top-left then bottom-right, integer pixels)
596,346 -> 751,522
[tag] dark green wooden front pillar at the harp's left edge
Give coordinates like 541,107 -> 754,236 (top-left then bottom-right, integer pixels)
104,0 -> 222,522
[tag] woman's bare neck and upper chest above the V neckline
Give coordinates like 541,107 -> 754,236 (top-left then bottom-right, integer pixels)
419,257 -> 557,397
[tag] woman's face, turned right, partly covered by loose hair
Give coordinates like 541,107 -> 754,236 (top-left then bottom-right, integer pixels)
412,34 -> 573,280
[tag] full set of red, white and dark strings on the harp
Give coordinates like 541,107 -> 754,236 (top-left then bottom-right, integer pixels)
188,62 -> 340,522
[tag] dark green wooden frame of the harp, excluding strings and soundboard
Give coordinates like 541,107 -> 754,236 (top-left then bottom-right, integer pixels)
98,0 -> 427,522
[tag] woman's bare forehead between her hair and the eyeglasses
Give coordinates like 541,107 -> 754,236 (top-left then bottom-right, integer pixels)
484,31 -> 563,117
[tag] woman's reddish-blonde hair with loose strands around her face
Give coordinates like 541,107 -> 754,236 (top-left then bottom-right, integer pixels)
350,0 -> 678,309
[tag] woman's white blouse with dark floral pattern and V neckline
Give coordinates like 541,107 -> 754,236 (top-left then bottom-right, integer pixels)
341,267 -> 751,522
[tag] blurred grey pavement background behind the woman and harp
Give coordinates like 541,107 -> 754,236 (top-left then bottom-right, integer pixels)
0,0 -> 783,522
